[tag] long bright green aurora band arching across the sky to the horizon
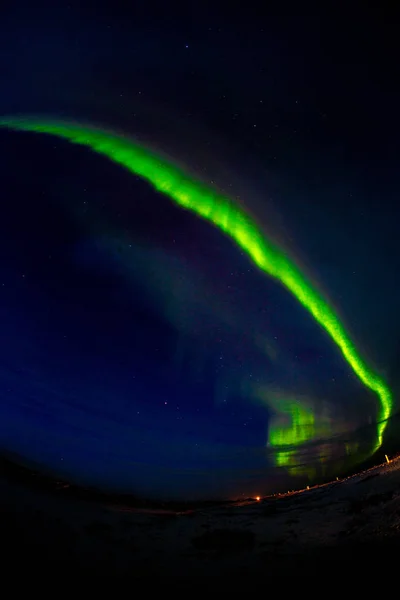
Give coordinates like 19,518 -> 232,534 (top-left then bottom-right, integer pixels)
0,118 -> 393,451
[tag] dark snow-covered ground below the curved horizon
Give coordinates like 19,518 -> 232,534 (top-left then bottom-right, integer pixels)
0,458 -> 400,577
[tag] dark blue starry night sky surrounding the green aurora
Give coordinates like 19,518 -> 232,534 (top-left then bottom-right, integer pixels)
0,2 -> 400,499
